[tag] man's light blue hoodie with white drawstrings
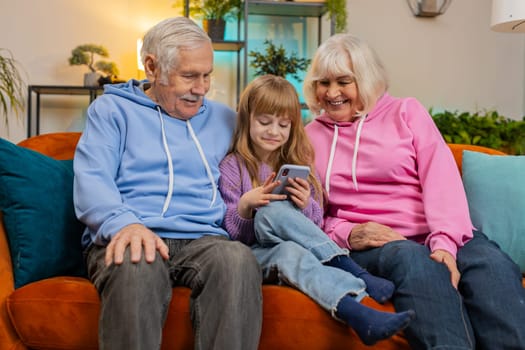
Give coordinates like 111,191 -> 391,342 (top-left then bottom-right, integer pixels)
74,80 -> 235,248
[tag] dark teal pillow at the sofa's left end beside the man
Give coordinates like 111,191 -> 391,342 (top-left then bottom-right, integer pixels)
0,138 -> 85,288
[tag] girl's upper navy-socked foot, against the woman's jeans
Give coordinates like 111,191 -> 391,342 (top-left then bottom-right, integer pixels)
325,255 -> 395,303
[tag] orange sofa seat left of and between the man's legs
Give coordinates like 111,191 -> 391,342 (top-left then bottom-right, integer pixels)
7,277 -> 193,350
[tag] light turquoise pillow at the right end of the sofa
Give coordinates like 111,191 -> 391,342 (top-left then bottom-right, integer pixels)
462,151 -> 525,273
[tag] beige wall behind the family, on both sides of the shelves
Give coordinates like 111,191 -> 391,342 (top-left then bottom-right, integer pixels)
0,0 -> 525,142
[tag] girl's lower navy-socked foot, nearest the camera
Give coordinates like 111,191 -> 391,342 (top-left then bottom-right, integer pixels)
336,295 -> 415,345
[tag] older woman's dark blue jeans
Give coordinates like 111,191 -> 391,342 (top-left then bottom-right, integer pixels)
351,232 -> 525,350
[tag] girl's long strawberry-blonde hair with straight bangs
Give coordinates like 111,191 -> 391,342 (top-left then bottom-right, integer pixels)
230,74 -> 322,203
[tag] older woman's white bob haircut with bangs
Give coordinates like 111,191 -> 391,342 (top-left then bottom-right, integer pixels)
303,33 -> 388,115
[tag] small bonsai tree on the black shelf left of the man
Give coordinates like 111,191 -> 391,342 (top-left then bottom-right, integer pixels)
69,44 -> 119,86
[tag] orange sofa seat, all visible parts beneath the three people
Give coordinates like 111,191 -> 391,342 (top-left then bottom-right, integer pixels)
7,277 -> 409,350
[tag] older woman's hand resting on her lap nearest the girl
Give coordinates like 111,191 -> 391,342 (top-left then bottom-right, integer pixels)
348,222 -> 406,250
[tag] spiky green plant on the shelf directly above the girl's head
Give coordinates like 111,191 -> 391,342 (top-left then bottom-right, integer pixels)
248,39 -> 311,81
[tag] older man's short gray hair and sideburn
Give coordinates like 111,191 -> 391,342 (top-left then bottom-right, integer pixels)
140,17 -> 211,84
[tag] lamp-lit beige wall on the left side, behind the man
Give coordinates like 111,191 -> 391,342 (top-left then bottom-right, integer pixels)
0,0 -> 235,142
